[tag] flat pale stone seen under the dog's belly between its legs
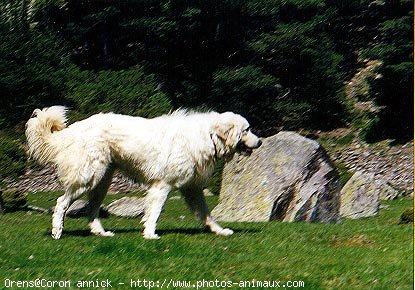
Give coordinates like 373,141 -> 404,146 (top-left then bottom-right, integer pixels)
106,196 -> 145,217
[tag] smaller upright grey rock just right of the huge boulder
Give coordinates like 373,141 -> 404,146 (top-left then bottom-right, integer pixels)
340,171 -> 380,219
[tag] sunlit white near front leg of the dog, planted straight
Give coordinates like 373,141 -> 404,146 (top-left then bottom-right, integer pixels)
142,183 -> 171,240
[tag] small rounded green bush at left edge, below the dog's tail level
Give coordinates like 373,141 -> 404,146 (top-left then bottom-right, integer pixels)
0,133 -> 26,184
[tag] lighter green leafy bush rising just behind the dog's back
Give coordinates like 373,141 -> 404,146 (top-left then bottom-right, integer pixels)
67,67 -> 172,117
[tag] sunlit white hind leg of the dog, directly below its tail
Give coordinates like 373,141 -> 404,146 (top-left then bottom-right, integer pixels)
52,187 -> 87,240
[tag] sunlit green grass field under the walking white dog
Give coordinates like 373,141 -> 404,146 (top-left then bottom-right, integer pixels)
0,193 -> 414,289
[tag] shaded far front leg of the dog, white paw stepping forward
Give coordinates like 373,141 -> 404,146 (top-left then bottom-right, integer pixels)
181,188 -> 233,236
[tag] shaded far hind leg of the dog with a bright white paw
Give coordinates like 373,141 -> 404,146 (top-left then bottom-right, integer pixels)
88,166 -> 114,237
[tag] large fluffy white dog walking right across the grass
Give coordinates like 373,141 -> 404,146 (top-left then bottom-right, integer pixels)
26,106 -> 261,239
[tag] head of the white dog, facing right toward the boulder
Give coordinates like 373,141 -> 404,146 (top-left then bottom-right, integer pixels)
213,112 -> 262,156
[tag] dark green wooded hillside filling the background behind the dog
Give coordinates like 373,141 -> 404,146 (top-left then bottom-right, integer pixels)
0,0 -> 413,178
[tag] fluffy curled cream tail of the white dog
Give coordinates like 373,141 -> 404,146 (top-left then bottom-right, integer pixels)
26,106 -> 67,164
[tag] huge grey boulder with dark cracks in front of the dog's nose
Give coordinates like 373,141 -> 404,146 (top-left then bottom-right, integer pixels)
212,132 -> 340,222
